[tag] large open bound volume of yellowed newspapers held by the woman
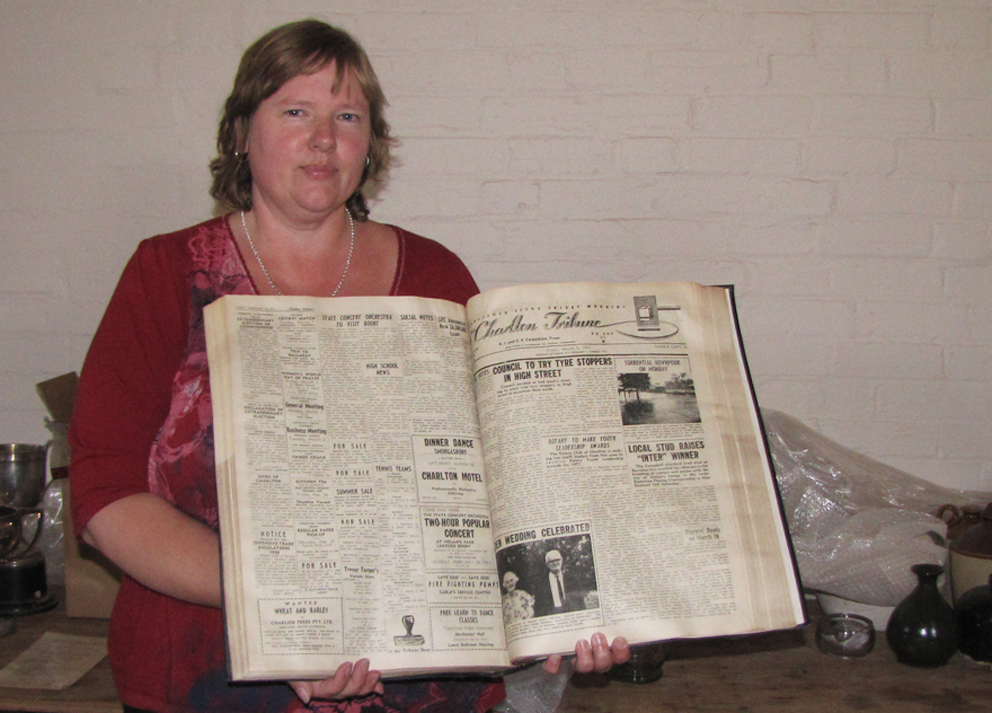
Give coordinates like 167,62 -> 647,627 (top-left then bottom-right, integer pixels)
205,283 -> 806,680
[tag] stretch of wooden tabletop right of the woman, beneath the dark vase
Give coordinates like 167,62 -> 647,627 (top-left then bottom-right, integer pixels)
558,625 -> 992,713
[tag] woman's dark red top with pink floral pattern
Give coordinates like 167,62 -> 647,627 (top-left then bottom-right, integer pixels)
70,217 -> 503,713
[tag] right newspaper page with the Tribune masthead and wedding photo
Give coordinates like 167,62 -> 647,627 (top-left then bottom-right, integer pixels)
468,283 -> 804,659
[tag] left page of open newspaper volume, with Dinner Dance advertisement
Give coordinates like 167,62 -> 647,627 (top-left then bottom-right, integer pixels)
205,296 -> 509,680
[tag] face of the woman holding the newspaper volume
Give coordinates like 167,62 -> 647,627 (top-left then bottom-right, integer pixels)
245,62 -> 370,225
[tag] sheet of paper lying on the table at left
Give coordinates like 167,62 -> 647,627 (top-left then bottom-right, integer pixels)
0,631 -> 107,691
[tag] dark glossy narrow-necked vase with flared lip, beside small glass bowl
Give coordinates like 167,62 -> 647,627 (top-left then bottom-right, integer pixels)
885,564 -> 958,668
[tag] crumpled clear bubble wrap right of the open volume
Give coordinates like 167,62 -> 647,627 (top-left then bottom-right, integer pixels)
761,409 -> 992,606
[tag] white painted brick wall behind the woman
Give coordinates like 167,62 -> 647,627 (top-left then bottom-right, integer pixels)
0,0 -> 992,490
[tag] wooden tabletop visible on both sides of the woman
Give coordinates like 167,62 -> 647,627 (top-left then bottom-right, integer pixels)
0,592 -> 992,713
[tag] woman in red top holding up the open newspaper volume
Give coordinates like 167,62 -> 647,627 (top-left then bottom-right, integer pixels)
70,20 -> 628,712
